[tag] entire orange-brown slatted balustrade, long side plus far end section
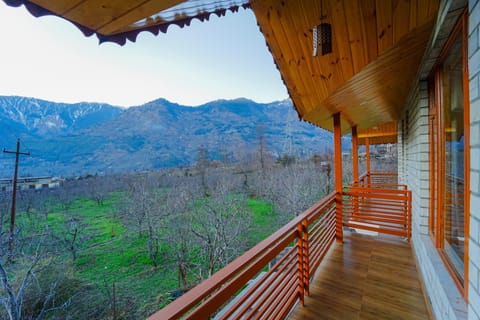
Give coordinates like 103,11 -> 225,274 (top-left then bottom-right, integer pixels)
149,173 -> 412,320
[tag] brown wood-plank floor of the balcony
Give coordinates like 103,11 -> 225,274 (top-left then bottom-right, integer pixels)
289,233 -> 429,320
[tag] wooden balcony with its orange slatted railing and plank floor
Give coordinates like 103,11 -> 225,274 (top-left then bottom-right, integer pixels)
150,176 -> 428,320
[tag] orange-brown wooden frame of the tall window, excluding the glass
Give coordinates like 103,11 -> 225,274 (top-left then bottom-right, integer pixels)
428,9 -> 470,301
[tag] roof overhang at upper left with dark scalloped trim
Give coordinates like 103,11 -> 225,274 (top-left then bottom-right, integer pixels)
4,0 -> 249,45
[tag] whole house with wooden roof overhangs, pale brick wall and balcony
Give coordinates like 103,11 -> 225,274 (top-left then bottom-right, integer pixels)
4,0 -> 480,320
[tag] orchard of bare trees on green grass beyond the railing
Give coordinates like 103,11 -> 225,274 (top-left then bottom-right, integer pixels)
0,144 -> 396,319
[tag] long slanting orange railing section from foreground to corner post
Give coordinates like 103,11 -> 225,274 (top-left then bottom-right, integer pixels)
149,192 -> 335,320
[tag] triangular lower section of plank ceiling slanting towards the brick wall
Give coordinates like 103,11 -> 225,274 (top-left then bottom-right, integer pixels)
304,18 -> 431,130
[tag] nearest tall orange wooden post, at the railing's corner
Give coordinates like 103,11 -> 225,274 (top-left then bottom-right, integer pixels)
333,113 -> 343,242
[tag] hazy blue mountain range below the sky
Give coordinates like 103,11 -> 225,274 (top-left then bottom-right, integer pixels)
0,96 -> 342,177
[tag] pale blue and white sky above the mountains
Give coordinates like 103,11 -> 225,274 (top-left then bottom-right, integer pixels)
0,2 -> 288,107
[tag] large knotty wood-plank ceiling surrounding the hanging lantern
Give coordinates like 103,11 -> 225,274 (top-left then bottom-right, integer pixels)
251,0 -> 438,132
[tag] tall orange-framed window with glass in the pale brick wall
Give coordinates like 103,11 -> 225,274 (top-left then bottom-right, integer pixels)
429,10 -> 469,295
